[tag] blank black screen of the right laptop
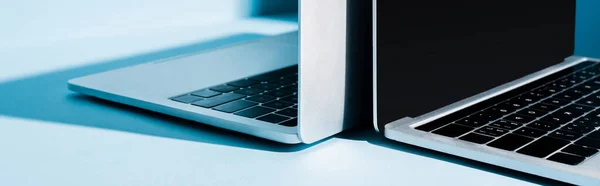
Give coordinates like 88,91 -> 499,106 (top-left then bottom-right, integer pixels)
375,0 -> 575,129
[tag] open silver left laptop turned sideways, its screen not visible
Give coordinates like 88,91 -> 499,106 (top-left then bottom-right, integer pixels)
68,0 -> 370,144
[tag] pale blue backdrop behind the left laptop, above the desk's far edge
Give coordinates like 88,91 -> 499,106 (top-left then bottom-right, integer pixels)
0,0 -> 297,48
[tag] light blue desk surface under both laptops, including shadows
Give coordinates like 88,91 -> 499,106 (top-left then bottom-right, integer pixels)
0,9 -> 598,186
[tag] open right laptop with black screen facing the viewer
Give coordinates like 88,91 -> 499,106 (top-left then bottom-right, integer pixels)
373,0 -> 600,185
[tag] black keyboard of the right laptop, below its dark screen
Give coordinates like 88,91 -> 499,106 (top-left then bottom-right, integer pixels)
416,61 -> 600,165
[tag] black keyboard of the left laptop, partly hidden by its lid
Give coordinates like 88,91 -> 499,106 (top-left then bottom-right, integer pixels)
170,65 -> 298,127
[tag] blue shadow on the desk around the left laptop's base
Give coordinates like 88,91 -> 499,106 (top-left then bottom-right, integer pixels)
0,34 -> 310,152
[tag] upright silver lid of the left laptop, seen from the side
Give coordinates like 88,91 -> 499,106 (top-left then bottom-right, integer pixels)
298,0 -> 372,143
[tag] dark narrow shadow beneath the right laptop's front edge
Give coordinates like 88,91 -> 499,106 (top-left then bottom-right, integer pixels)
335,125 -> 570,185
